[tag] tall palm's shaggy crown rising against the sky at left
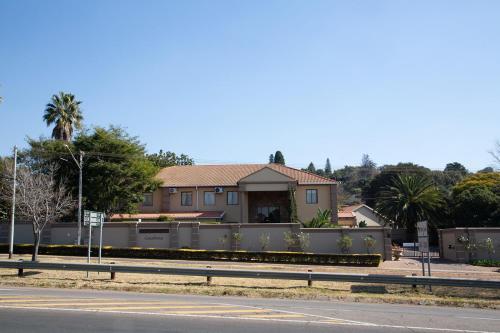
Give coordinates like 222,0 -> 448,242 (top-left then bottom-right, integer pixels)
43,92 -> 83,141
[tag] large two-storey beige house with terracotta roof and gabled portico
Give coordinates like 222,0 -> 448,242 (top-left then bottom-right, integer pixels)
112,164 -> 337,223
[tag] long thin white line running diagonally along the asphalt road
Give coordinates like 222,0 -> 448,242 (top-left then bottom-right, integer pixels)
0,306 -> 500,333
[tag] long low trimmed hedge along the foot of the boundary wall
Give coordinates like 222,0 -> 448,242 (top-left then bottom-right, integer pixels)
0,244 -> 382,267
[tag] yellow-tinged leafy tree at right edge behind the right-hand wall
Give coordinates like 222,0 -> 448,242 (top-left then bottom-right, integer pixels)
452,172 -> 500,227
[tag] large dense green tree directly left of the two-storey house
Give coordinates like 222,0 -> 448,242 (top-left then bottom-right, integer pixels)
74,127 -> 159,215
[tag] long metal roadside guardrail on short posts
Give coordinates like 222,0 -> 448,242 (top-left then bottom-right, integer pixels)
0,260 -> 500,289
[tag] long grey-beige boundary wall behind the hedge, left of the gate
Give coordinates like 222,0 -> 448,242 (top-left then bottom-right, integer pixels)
0,222 -> 392,260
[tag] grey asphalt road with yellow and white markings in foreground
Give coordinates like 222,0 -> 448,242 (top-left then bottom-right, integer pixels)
0,288 -> 500,333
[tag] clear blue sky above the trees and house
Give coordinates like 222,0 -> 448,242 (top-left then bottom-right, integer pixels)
0,0 -> 500,170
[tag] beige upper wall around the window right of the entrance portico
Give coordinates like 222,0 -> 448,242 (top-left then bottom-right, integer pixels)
296,185 -> 336,222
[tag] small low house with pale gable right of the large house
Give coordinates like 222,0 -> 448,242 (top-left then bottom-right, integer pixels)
338,204 -> 390,227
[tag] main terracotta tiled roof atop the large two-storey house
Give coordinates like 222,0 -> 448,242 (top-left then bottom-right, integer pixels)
157,164 -> 335,187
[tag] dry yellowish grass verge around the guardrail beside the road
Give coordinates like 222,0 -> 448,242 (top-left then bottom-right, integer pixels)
0,257 -> 500,309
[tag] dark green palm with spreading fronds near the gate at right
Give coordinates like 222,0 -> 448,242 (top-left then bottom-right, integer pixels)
375,174 -> 444,235
